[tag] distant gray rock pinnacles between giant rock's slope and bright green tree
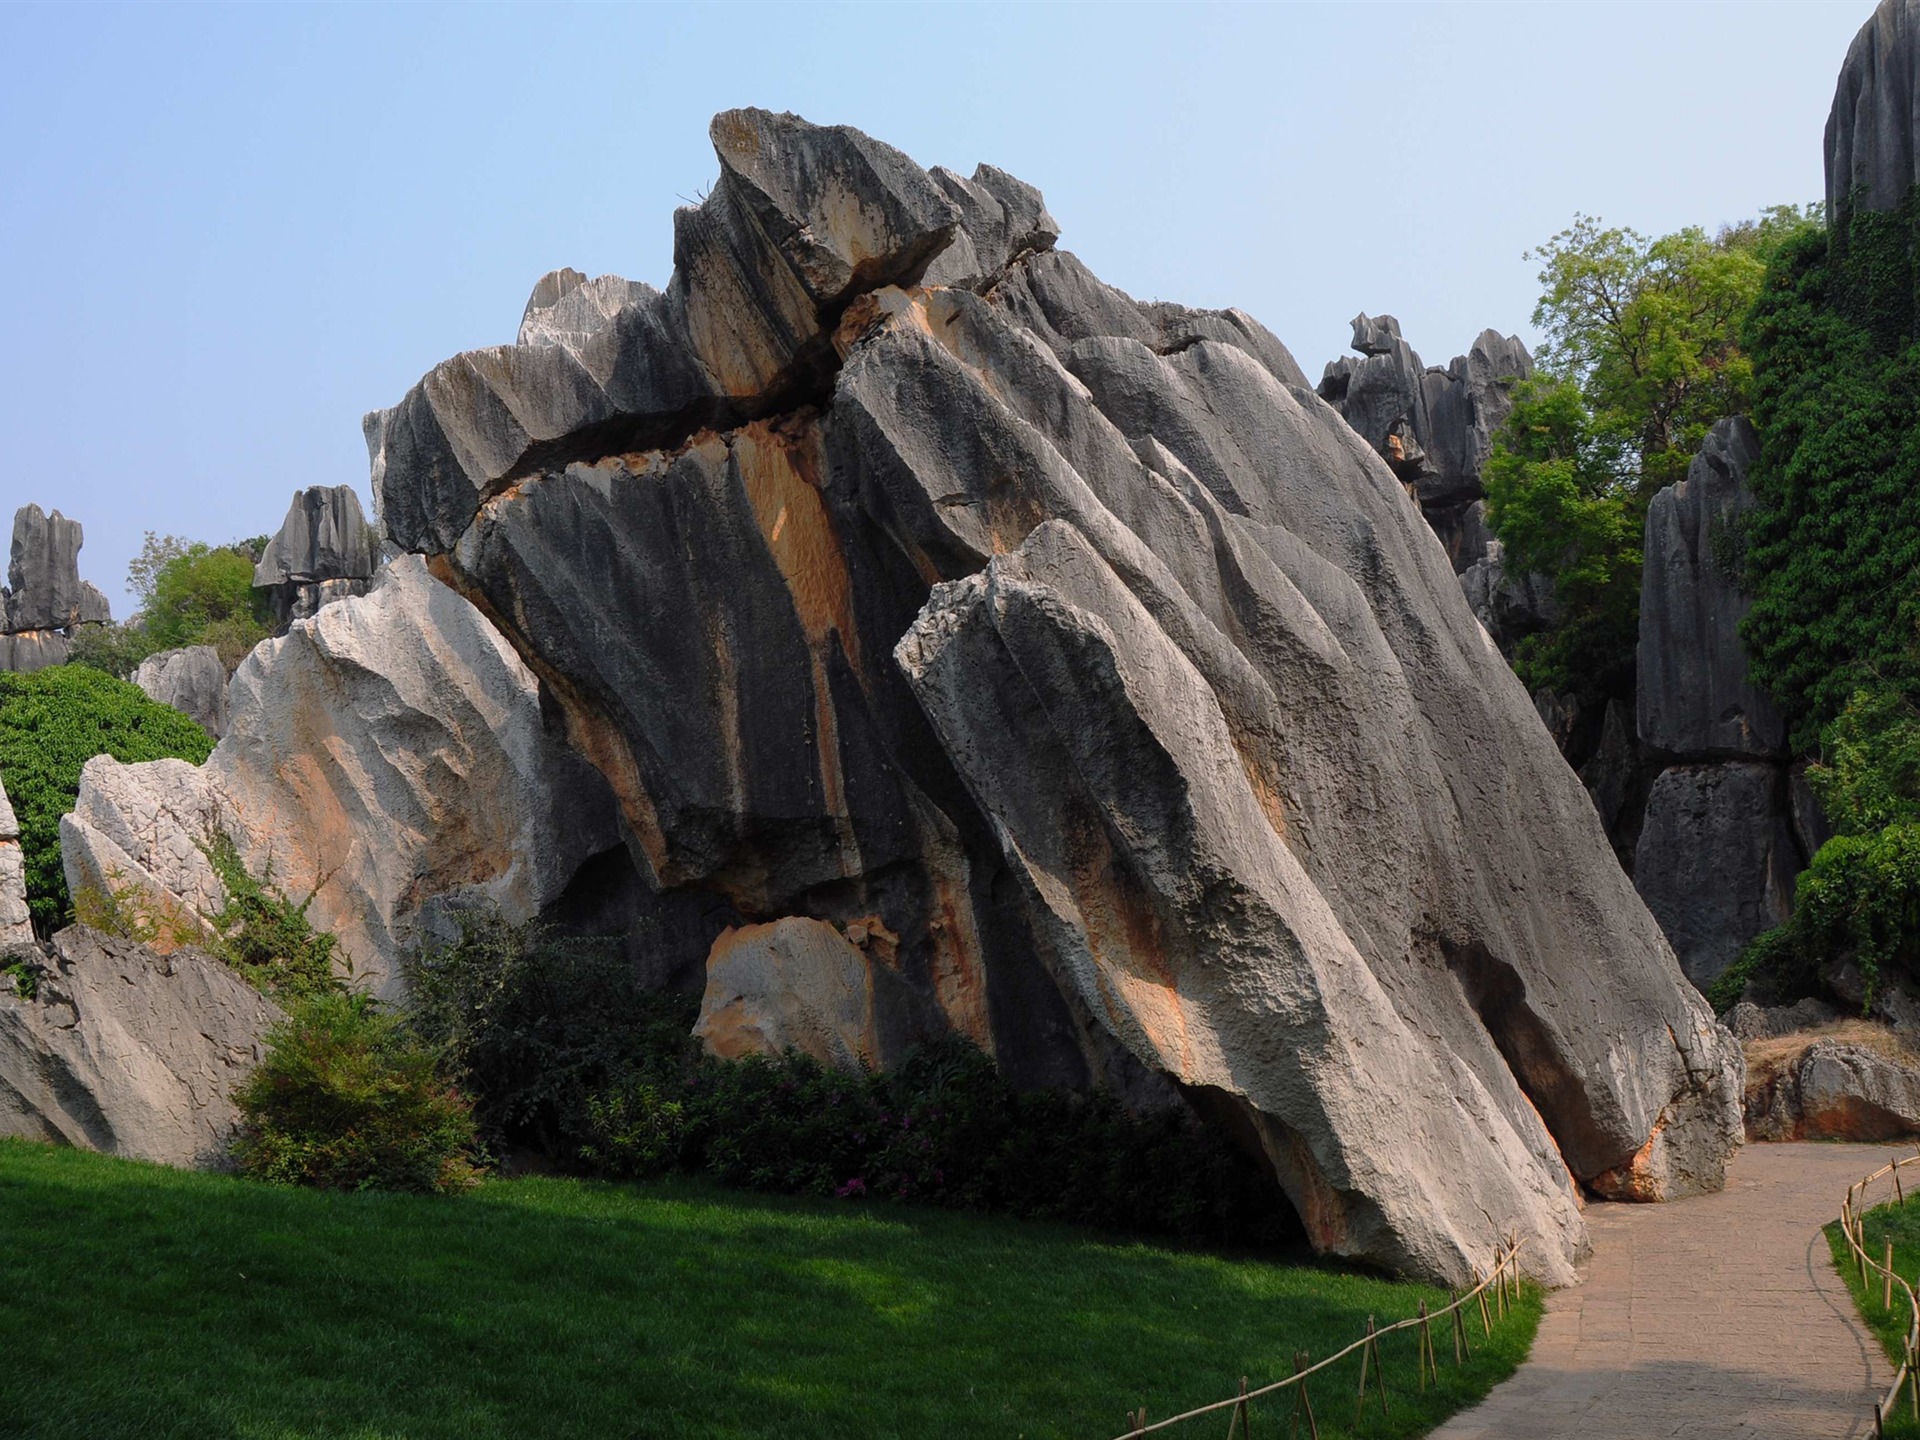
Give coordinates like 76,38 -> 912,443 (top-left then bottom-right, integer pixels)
1319,313 -> 1542,583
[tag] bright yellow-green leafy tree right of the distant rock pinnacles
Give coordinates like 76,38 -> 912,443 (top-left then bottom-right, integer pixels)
1486,205 -> 1818,701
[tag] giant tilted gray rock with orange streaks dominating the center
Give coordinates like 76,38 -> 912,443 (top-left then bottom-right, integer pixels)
357,111 -> 1741,1281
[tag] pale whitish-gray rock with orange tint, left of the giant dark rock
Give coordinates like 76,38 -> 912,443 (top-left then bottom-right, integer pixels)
60,557 -> 620,995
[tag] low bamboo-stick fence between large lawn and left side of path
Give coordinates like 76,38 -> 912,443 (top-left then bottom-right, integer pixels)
1114,1228 -> 1528,1440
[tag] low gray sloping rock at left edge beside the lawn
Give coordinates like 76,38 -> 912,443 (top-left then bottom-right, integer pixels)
0,925 -> 282,1167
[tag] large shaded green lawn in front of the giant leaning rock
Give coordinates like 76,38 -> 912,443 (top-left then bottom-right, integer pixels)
0,1140 -> 1538,1440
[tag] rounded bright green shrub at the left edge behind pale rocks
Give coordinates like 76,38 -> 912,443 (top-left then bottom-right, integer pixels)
0,664 -> 213,933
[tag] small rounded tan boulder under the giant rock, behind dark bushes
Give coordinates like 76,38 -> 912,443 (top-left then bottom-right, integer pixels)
693,916 -> 931,1069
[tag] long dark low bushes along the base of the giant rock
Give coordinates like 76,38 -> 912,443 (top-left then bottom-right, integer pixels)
409,916 -> 1288,1242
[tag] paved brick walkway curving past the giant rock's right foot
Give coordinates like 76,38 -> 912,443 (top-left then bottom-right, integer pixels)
1434,1144 -> 1893,1440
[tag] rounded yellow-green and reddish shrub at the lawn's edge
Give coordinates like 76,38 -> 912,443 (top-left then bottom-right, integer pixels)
234,991 -> 478,1190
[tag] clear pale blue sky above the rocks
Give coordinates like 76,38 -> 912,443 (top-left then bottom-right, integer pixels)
0,0 -> 1872,614
